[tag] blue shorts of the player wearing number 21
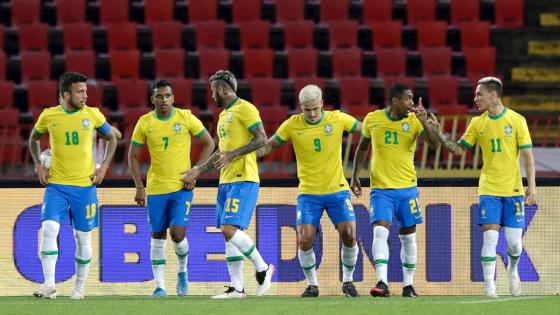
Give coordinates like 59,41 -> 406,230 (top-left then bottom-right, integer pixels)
369,186 -> 423,228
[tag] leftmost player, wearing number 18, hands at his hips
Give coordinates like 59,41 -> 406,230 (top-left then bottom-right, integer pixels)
29,72 -> 117,299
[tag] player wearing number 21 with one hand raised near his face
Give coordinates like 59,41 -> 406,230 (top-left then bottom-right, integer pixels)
350,83 -> 439,297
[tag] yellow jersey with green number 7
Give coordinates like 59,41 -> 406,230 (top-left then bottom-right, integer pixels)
131,108 -> 206,195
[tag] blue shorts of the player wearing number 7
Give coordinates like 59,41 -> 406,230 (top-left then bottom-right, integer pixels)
147,189 -> 193,233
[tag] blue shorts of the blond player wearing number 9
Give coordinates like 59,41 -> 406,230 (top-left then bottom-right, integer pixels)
296,190 -> 356,229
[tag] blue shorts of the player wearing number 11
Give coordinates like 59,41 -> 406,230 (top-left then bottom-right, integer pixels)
478,195 -> 525,228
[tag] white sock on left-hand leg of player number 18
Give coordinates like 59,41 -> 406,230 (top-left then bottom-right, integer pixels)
41,220 -> 60,286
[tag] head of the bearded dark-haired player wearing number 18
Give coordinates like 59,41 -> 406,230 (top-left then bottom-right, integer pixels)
58,72 -> 87,110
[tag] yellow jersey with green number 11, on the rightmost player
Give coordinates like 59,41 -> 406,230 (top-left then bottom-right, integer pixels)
459,107 -> 532,197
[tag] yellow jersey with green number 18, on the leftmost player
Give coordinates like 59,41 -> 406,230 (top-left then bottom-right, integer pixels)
34,105 -> 111,187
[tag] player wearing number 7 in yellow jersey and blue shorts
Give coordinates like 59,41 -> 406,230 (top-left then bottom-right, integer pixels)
128,80 -> 214,297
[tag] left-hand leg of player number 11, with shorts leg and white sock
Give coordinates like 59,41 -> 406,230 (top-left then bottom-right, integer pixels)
478,195 -> 503,297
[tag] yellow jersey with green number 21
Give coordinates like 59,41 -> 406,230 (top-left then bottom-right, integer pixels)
362,109 -> 424,189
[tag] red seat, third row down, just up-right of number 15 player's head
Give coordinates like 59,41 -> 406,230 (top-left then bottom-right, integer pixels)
243,49 -> 274,80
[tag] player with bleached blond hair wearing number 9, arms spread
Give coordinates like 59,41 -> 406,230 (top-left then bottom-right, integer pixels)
257,85 -> 362,297
